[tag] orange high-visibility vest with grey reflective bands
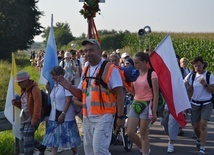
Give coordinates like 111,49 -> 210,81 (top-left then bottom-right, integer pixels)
82,62 -> 116,116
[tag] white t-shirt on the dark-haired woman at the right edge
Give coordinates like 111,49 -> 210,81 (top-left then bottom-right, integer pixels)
189,72 -> 214,105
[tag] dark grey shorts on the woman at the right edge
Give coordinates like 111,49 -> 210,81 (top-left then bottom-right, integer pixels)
192,103 -> 213,124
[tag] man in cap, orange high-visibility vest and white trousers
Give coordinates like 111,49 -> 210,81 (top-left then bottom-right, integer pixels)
59,39 -> 125,155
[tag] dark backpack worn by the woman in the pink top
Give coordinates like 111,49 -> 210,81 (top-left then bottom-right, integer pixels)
147,69 -> 165,117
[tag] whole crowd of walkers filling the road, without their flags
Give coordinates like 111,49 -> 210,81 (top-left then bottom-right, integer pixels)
13,39 -> 214,155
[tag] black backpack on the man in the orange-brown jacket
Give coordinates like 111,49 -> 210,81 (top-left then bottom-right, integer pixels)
30,87 -> 51,117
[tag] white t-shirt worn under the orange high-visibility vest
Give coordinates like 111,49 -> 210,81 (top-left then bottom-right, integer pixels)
78,60 -> 123,116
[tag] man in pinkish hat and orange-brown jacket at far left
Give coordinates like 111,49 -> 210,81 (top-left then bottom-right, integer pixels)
12,72 -> 45,155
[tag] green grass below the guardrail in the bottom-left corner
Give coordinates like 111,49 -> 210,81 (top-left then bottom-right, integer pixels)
0,130 -> 15,155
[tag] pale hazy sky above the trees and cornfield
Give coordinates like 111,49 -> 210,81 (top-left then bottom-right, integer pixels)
34,0 -> 214,41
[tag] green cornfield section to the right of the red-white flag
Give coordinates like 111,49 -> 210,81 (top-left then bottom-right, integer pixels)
171,33 -> 214,72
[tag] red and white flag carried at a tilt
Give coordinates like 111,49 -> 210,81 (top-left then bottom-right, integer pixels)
150,35 -> 191,127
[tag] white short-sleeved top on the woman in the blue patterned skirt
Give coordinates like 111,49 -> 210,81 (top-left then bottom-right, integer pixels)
49,84 -> 75,121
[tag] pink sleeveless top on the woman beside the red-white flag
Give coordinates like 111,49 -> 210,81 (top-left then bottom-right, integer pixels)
133,71 -> 158,101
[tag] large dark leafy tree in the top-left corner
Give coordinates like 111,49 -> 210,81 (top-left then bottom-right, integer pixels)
0,0 -> 43,59
